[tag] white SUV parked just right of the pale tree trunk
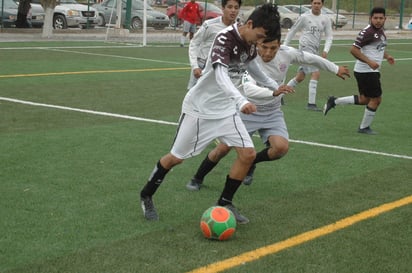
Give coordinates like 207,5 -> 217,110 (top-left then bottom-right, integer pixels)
31,0 -> 97,29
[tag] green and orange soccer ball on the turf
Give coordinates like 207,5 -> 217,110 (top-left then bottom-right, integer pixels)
200,206 -> 236,241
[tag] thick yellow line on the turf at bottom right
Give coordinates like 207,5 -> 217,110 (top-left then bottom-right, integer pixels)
189,195 -> 412,273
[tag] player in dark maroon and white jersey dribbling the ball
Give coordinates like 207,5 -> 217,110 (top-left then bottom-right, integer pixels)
140,4 -> 293,224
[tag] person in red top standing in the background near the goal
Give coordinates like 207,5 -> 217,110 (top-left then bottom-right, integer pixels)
179,0 -> 202,47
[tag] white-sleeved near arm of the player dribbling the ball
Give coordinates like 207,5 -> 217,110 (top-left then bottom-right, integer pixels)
213,63 -> 256,114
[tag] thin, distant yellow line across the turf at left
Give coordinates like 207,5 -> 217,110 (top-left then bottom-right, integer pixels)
0,67 -> 190,78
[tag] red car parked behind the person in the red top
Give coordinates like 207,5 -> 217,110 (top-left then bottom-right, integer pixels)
166,2 -> 223,27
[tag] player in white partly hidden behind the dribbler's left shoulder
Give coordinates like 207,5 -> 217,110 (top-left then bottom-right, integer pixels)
187,0 -> 242,89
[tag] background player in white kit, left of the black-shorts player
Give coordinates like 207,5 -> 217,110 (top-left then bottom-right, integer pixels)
283,0 -> 333,111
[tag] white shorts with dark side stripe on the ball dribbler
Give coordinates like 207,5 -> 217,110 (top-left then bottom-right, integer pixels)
171,114 -> 254,159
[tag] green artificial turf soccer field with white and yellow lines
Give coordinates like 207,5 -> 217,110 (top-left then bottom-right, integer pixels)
0,39 -> 412,273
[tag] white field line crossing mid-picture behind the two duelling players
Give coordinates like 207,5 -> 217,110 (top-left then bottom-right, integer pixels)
0,97 -> 412,159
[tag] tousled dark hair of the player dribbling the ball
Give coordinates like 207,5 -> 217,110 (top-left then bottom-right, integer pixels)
247,3 -> 280,37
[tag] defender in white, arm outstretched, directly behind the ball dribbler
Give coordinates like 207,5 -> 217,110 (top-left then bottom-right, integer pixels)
186,33 -> 349,190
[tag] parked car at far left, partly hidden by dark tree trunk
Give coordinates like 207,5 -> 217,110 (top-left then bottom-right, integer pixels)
0,0 -> 44,28
